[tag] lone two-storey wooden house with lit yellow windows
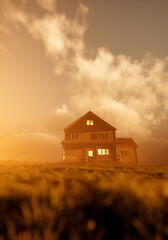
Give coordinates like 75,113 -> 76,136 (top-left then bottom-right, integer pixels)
62,111 -> 137,163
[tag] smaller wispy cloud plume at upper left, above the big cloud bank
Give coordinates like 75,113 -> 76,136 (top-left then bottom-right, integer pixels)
18,4 -> 88,75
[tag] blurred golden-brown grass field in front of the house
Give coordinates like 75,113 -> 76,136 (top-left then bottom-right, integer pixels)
0,161 -> 168,240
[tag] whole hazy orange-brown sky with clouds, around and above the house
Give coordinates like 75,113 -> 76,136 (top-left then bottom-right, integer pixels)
0,0 -> 168,164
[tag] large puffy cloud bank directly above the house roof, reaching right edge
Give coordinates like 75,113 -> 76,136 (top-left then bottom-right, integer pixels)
71,48 -> 168,140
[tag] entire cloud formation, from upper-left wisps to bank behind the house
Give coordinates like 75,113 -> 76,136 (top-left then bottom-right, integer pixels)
0,0 -> 168,162
